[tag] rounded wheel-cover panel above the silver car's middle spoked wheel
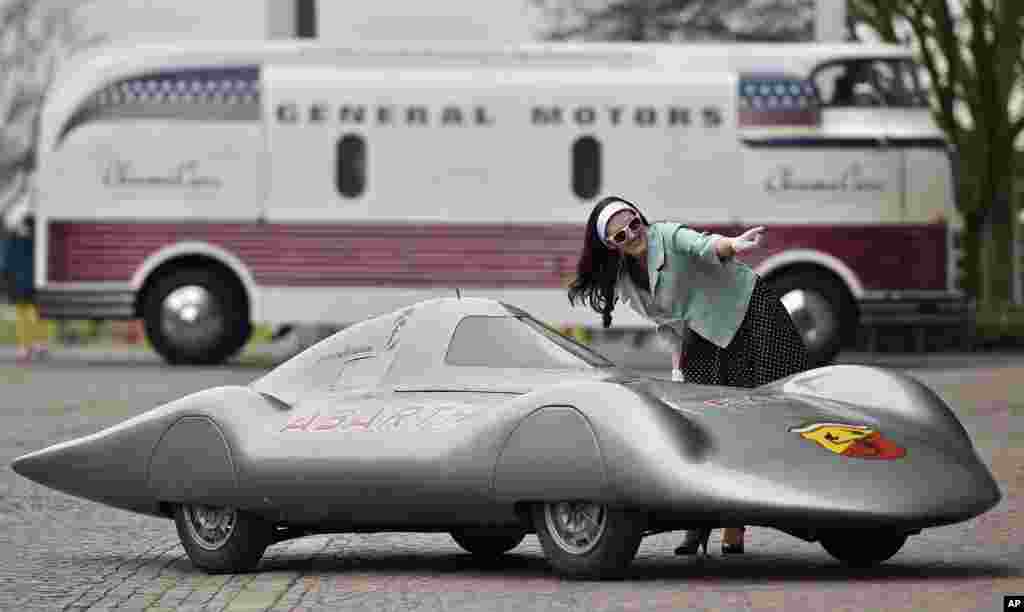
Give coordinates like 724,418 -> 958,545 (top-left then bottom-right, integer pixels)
492,405 -> 611,502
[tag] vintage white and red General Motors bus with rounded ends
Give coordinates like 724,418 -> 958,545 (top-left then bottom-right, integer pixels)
29,41 -> 963,364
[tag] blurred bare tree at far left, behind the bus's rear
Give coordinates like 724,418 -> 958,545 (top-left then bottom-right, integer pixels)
0,0 -> 101,184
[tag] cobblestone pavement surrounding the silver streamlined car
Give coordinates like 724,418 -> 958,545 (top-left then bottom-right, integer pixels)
0,362 -> 1024,612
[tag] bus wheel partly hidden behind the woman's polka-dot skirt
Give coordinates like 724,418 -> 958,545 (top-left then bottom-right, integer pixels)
770,271 -> 855,367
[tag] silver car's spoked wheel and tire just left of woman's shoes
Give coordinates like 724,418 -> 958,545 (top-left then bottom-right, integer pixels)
532,501 -> 644,579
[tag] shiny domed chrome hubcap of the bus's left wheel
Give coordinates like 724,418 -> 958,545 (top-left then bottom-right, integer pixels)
160,285 -> 225,347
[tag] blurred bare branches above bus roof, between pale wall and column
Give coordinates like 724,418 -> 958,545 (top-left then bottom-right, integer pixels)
529,0 -> 814,42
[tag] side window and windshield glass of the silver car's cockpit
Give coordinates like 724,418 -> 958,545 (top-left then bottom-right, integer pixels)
444,316 -> 614,369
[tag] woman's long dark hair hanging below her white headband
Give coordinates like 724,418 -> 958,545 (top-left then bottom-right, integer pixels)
568,195 -> 650,327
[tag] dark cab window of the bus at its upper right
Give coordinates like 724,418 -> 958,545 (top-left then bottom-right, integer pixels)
813,58 -> 928,108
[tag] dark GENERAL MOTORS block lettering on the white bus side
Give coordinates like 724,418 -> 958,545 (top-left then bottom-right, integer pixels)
275,101 -> 723,128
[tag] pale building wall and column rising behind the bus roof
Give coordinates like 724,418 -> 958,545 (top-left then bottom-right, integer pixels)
66,0 -> 846,45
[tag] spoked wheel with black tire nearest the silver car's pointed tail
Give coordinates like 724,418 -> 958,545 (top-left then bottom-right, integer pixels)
174,505 -> 273,574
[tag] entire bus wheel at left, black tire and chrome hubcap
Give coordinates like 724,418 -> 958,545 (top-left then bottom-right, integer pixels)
142,268 -> 252,365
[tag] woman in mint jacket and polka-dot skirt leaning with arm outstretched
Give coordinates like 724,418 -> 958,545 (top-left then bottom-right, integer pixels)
568,198 -> 808,555
